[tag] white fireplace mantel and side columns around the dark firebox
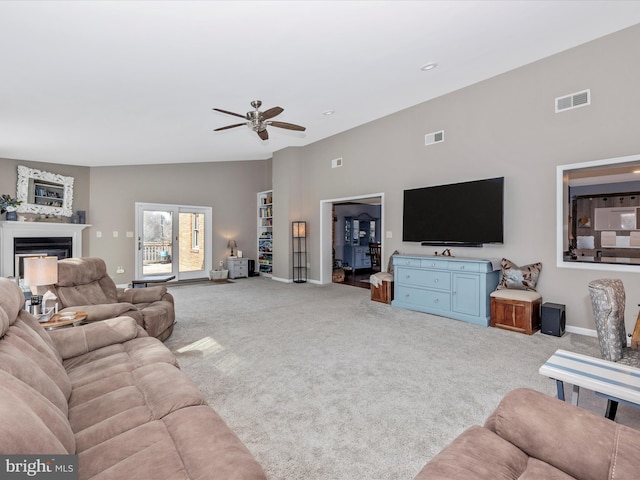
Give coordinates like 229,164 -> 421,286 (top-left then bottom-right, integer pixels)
0,221 -> 91,277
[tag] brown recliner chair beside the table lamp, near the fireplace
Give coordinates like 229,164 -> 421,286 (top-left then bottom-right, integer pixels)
48,258 -> 175,340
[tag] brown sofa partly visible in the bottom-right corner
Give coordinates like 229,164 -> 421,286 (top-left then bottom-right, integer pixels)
415,389 -> 640,480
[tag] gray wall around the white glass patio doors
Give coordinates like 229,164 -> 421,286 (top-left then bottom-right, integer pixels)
88,160 -> 271,284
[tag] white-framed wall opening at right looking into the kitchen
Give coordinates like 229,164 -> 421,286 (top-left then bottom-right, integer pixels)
556,155 -> 640,272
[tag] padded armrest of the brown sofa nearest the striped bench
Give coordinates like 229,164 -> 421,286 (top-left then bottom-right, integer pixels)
485,389 -> 640,480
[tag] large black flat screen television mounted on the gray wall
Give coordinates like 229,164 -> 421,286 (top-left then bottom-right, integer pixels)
402,177 -> 504,247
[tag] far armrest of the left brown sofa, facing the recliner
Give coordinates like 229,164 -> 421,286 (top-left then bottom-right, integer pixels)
49,317 -> 142,360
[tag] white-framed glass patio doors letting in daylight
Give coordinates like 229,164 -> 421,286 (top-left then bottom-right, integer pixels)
136,203 -> 212,280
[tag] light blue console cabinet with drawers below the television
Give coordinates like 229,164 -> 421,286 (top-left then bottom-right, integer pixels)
391,255 -> 500,327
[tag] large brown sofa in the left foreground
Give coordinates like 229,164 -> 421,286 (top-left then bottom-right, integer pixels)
0,278 -> 266,480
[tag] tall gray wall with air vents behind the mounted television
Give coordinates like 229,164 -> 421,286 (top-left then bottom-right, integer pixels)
273,26 -> 640,329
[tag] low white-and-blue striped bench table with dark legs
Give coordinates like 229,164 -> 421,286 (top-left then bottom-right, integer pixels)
539,350 -> 640,420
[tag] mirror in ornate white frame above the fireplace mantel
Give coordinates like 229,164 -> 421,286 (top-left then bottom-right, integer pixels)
16,165 -> 73,217
